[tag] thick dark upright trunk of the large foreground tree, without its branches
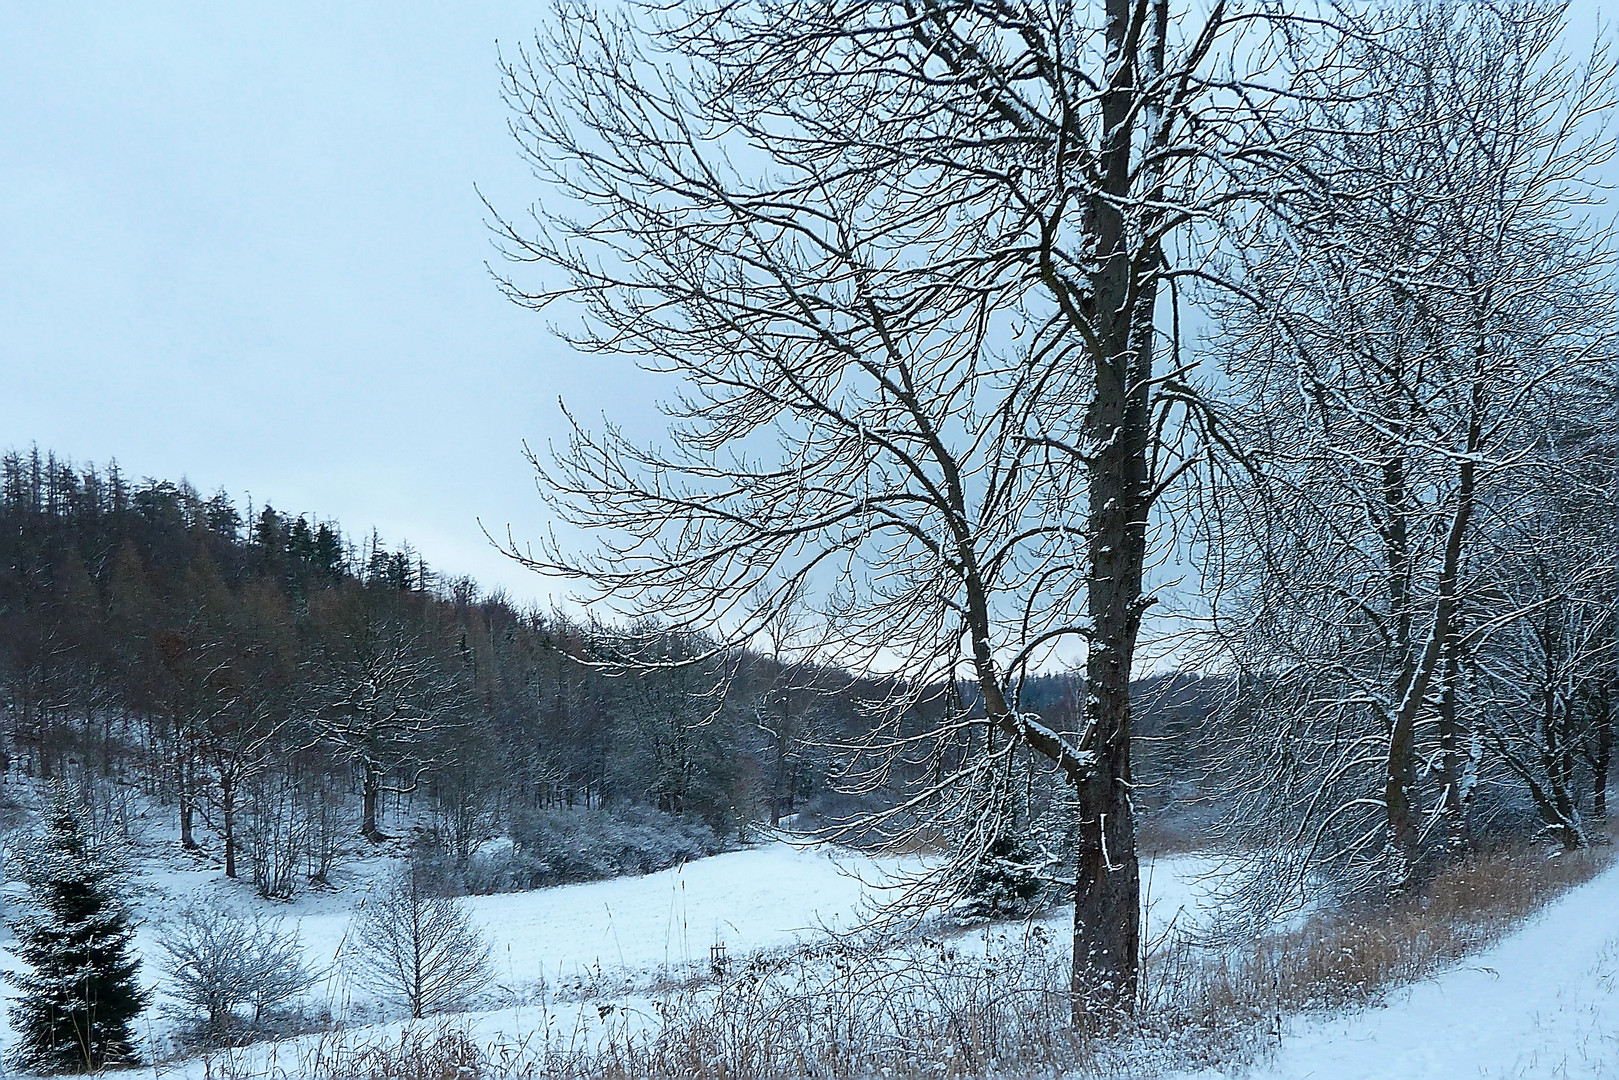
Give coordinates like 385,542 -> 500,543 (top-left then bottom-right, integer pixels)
1072,0 -> 1169,1023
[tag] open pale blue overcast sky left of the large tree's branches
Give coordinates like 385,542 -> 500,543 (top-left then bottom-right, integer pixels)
0,0 -> 1619,599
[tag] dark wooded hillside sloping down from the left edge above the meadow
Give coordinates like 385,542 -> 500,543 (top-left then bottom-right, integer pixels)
0,450 -> 874,895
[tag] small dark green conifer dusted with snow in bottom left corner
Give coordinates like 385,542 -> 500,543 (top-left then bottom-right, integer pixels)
5,789 -> 149,1072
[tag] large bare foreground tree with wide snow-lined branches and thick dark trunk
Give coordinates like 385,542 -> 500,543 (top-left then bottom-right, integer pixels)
499,0 -> 1323,1015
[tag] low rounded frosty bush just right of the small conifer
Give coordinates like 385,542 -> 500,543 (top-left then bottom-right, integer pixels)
157,902 -> 316,1041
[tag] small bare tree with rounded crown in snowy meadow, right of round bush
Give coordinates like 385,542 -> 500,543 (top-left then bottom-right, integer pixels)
355,866 -> 494,1020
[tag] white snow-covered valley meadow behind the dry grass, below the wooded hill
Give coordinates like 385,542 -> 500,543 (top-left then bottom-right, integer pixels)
0,819 -> 1208,1072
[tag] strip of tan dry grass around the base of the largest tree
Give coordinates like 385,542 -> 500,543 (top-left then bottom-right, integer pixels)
186,847 -> 1611,1080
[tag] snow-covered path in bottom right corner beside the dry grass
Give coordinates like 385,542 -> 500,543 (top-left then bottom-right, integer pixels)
1187,870 -> 1619,1080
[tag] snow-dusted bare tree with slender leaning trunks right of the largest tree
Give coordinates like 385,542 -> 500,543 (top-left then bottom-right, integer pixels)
1205,0 -> 1614,886
